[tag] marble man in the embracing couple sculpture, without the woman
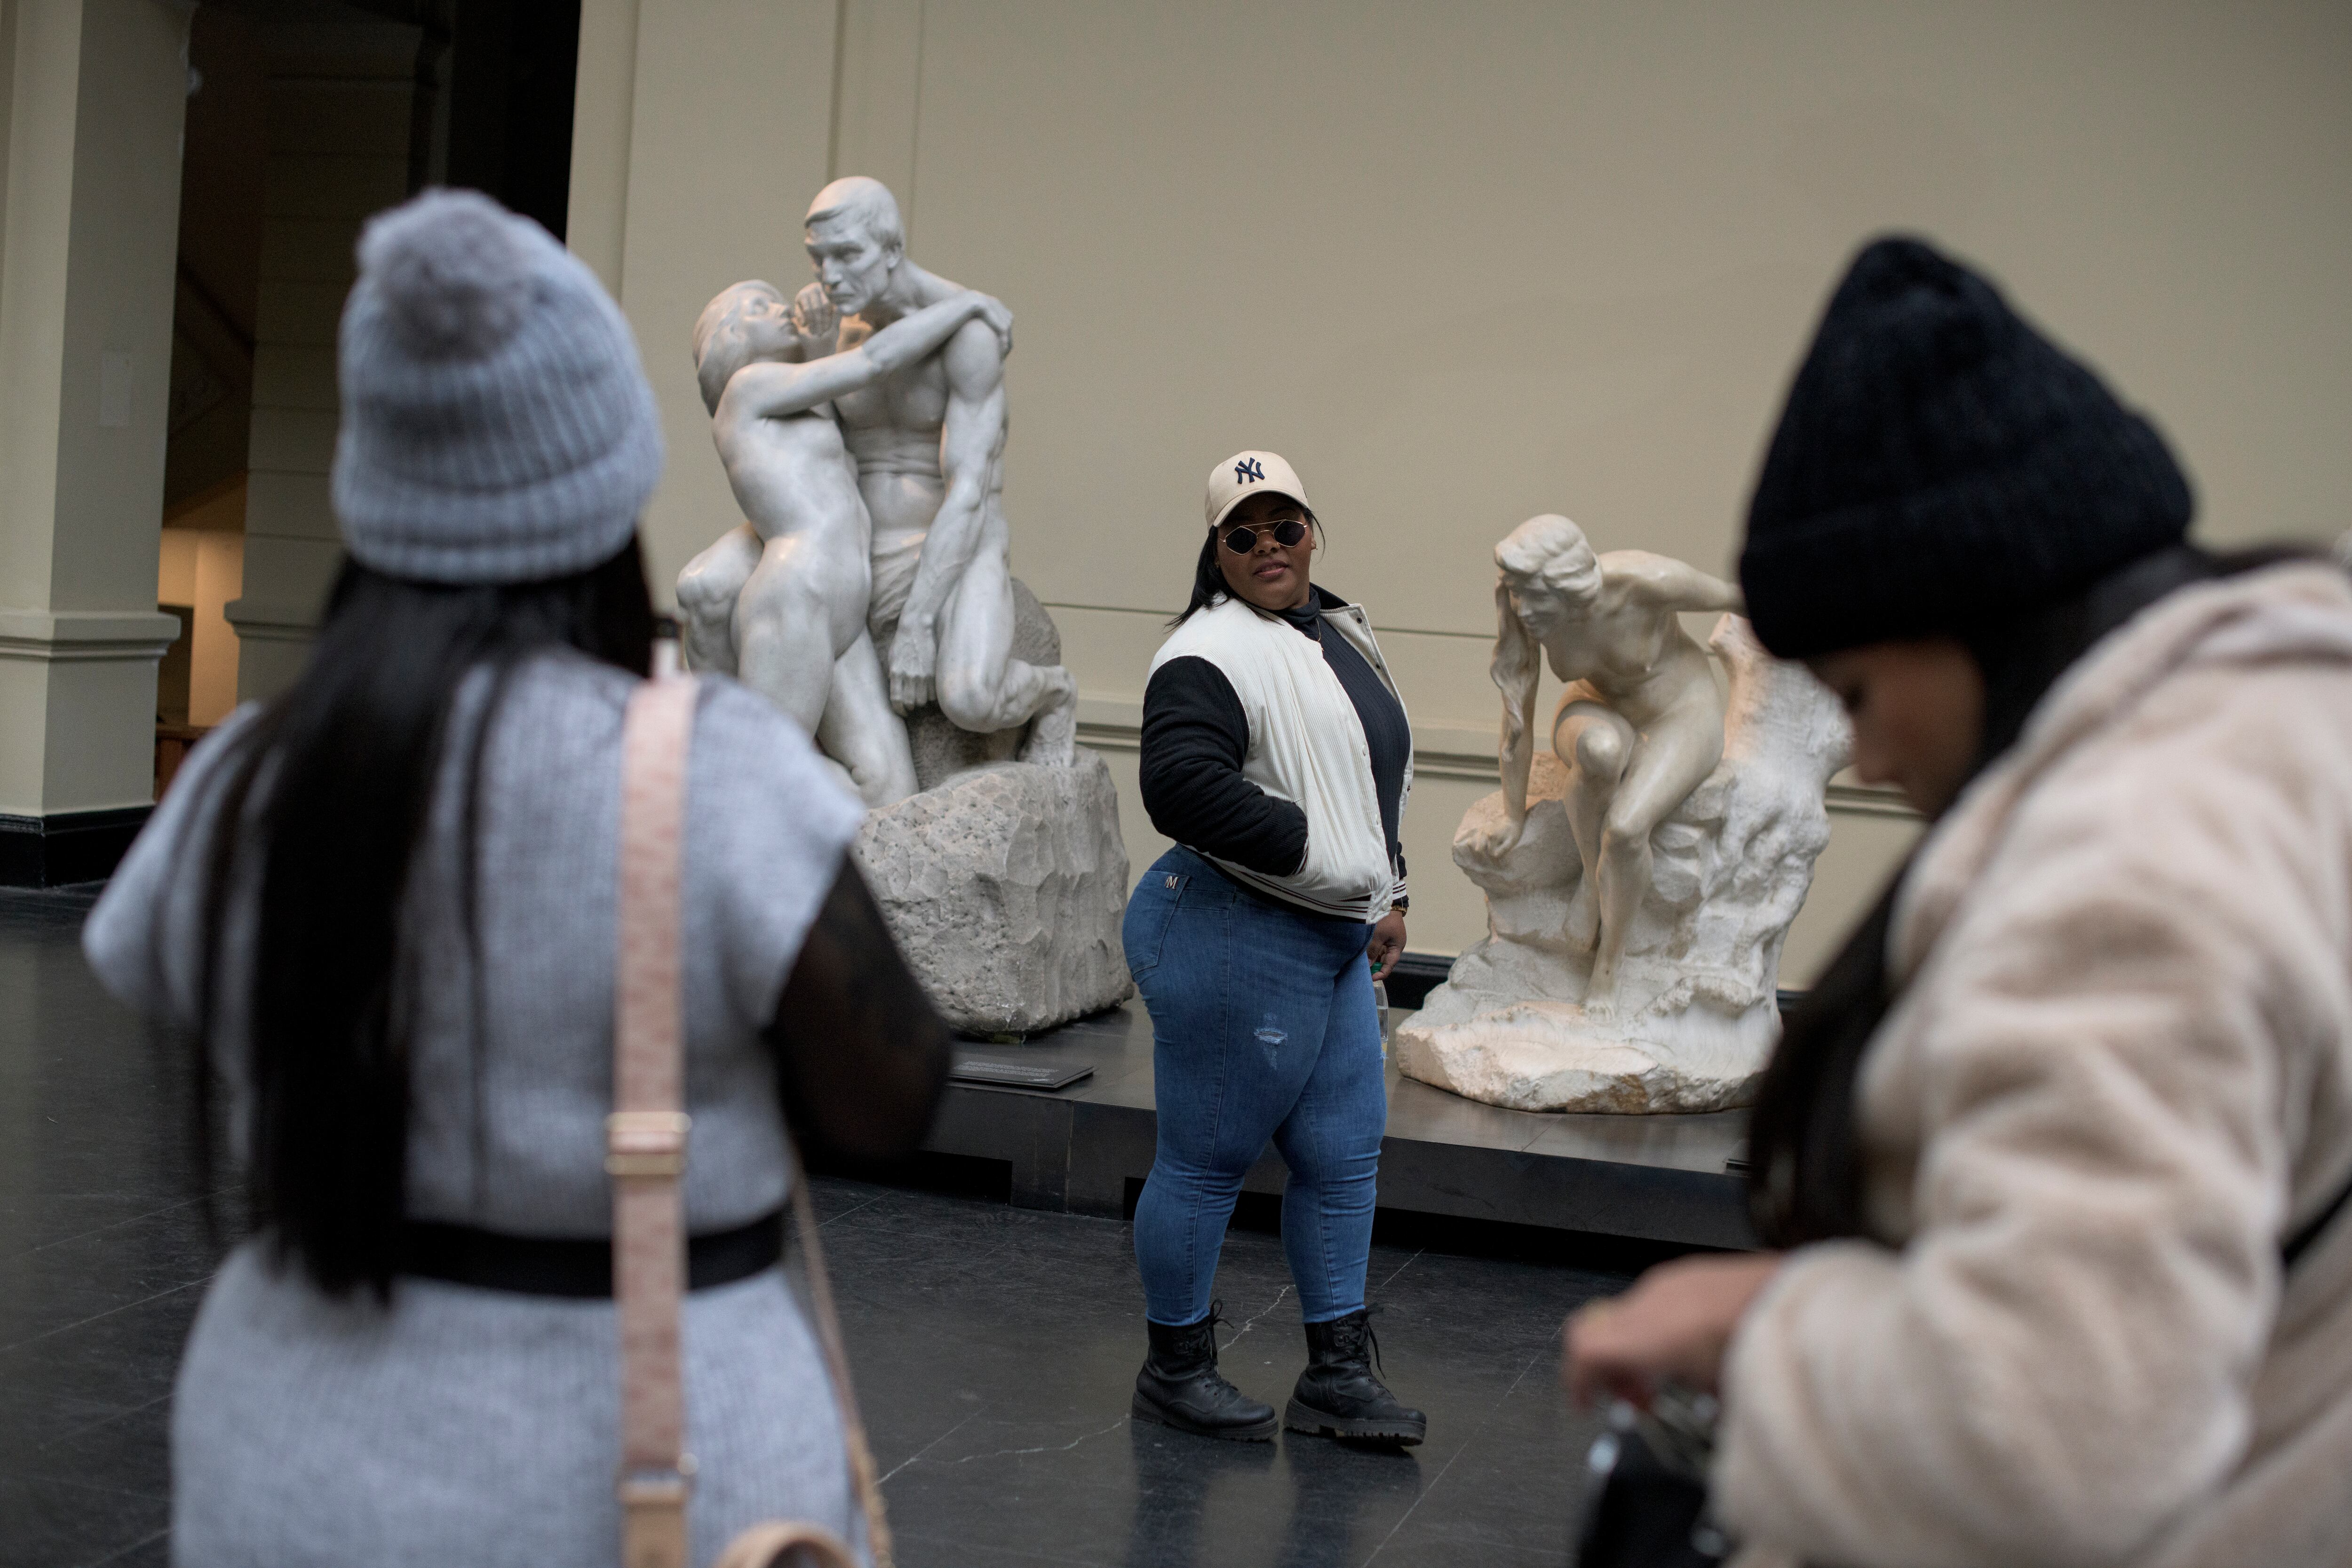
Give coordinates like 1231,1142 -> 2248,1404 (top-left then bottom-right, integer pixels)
797,176 -> 1077,764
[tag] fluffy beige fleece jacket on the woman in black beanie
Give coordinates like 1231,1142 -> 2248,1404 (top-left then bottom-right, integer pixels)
1715,564 -> 2352,1568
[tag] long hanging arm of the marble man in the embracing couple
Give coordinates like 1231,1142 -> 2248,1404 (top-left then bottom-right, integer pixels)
889,325 -> 1004,712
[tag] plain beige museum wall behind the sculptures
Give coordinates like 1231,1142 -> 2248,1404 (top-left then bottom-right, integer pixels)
572,0 -> 2352,978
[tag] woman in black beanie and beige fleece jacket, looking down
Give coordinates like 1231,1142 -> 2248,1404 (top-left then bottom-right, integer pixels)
1569,240 -> 2352,1568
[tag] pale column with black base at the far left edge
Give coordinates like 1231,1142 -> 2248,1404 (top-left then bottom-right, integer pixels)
0,0 -> 188,886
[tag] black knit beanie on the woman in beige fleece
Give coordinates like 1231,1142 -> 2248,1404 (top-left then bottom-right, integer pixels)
1740,240 -> 2194,658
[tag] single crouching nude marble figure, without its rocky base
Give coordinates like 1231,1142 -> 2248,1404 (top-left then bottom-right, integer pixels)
1477,515 -> 1740,1023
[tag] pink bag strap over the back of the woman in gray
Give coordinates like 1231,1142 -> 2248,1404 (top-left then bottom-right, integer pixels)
604,675 -> 891,1568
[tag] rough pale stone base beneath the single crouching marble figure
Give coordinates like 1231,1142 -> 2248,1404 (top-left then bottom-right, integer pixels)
1395,616 -> 1849,1112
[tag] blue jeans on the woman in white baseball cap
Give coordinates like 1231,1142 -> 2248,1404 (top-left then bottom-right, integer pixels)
1124,849 -> 1388,1323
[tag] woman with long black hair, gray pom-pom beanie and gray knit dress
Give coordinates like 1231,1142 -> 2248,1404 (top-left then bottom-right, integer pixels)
85,193 -> 948,1568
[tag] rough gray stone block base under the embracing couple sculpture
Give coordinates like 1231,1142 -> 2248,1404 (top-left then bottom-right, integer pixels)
856,578 -> 1136,1035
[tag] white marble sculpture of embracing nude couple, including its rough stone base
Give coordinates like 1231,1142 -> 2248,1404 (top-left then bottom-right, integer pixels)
677,179 -> 1134,1035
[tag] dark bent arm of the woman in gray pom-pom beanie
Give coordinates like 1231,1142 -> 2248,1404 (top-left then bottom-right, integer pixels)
767,856 -> 953,1159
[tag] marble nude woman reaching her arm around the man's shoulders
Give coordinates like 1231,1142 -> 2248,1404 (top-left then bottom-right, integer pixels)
677,282 -> 1011,806
